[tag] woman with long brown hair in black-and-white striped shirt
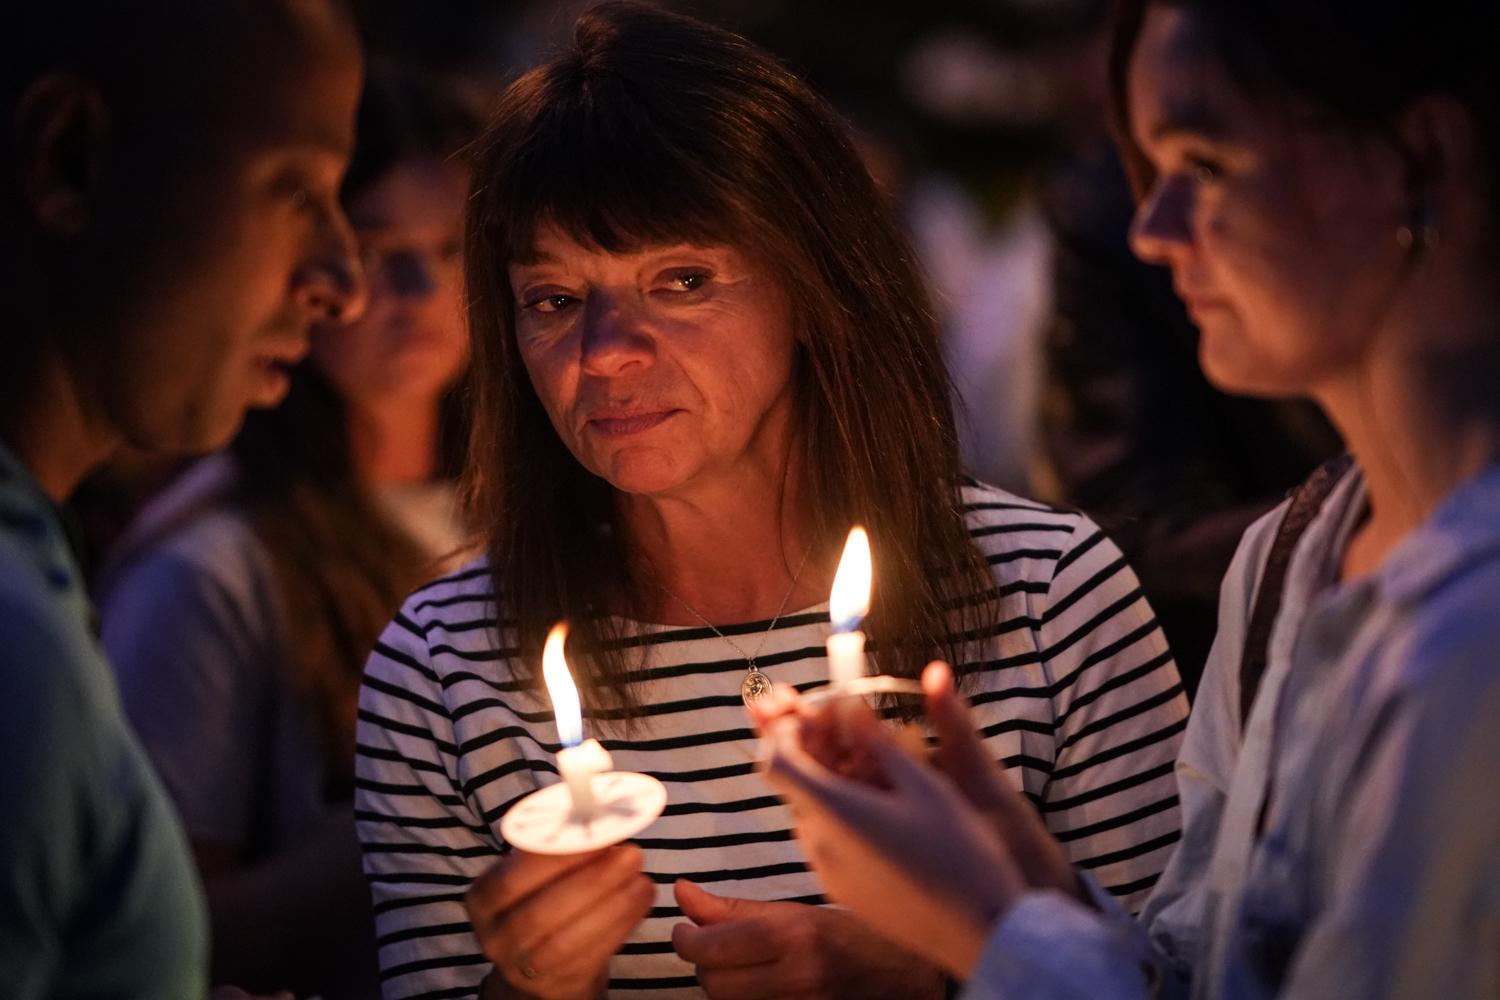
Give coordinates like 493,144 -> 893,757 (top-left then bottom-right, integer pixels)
356,3 -> 1187,997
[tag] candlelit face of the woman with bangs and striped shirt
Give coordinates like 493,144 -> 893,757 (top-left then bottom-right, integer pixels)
510,228 -> 795,496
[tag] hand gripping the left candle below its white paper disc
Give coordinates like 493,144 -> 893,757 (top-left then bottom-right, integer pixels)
464,844 -> 656,1000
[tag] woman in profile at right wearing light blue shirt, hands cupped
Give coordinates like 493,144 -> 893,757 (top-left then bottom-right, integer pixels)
768,0 -> 1500,997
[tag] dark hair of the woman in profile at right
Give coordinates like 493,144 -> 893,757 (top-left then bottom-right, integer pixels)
1110,0 -> 1500,203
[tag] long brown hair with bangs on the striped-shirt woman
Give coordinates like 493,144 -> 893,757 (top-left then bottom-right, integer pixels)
467,3 -> 993,718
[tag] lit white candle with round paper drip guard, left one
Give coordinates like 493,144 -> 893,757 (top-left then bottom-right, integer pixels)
500,624 -> 666,855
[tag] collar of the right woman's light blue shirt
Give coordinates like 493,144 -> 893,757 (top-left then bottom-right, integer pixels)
1380,463 -> 1500,604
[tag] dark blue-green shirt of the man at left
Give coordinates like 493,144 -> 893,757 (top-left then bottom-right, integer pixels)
0,445 -> 209,1000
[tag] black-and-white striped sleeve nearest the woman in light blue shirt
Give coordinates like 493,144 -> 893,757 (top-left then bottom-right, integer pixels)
1035,517 -> 1188,912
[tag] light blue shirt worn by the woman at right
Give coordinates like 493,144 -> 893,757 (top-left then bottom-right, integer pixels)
966,466 -> 1500,1000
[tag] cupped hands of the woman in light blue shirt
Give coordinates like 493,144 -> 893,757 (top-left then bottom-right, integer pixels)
758,664 -> 1083,978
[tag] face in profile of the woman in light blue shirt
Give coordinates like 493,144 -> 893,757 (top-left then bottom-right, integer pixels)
1128,6 -> 1412,396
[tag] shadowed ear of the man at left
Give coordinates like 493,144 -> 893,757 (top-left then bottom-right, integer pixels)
12,73 -> 111,237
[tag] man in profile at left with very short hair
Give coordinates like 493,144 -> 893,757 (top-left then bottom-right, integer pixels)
0,0 -> 363,999
